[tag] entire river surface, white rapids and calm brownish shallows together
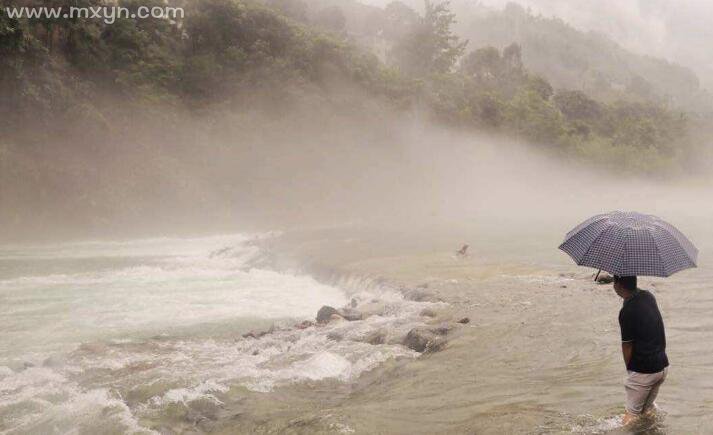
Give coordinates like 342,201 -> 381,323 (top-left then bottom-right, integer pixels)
0,221 -> 713,434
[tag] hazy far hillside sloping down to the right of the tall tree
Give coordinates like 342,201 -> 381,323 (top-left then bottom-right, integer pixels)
453,0 -> 713,112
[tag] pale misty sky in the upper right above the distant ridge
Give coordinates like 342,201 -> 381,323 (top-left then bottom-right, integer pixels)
361,0 -> 713,89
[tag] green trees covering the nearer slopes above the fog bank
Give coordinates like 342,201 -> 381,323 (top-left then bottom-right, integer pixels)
0,0 -> 689,172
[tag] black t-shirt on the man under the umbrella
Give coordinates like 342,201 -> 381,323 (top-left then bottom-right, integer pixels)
619,290 -> 668,373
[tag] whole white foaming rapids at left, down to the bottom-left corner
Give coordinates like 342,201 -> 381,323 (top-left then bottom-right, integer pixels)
0,236 -> 431,433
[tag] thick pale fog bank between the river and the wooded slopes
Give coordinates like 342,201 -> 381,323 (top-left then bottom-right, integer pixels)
2,99 -> 713,245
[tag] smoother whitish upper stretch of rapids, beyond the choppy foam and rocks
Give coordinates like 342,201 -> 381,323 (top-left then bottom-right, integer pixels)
0,236 -> 347,356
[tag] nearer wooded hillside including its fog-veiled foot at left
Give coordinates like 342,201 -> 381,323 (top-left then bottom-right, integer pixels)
0,0 -> 695,242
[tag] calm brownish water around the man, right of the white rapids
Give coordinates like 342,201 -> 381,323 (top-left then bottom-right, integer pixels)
214,220 -> 713,434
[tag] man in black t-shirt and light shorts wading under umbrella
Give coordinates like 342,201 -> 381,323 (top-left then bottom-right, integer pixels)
614,276 -> 668,425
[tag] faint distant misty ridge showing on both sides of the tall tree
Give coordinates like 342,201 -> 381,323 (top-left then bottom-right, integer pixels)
302,0 -> 713,114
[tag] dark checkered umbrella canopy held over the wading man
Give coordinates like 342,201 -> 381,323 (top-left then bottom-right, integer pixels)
560,211 -> 698,276
